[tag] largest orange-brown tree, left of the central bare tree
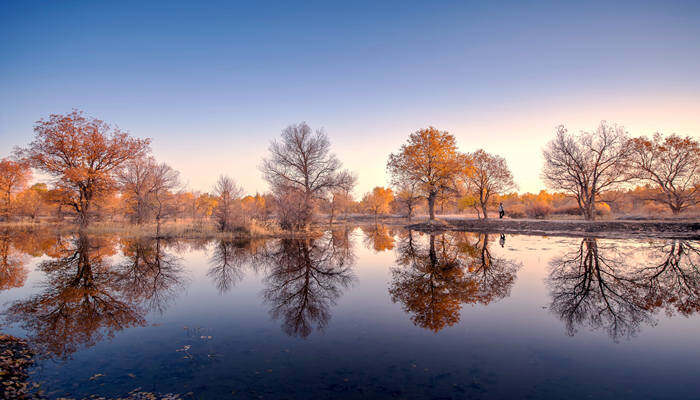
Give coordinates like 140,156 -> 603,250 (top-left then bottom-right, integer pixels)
18,110 -> 150,226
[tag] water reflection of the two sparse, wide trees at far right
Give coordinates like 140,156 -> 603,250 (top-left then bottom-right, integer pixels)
547,238 -> 700,341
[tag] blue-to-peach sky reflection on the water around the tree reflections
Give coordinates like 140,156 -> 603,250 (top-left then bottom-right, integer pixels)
0,229 -> 700,399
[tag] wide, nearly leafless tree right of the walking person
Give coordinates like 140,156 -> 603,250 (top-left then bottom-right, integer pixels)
542,121 -> 631,220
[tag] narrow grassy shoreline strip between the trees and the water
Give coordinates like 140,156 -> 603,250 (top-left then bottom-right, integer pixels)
0,216 -> 700,240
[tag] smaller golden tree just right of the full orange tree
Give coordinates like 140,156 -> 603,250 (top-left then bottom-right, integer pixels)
464,149 -> 517,219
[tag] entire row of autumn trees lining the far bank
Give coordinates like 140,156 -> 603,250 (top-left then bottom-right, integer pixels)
0,110 -> 700,230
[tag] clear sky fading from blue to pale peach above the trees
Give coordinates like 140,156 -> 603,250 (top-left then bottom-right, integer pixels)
0,0 -> 700,195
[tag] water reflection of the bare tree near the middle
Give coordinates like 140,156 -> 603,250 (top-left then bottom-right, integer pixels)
262,231 -> 355,338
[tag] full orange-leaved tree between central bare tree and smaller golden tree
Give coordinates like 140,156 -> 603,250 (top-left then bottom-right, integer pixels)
387,127 -> 465,221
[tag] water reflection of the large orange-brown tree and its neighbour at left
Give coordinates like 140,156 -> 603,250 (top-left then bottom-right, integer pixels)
6,234 -> 187,358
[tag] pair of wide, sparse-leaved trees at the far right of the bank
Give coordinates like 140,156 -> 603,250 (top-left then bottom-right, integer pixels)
542,122 -> 700,219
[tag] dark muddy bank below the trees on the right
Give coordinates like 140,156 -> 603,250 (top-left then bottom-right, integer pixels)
406,219 -> 700,240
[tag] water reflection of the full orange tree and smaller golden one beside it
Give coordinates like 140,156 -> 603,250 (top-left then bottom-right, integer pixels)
389,231 -> 520,332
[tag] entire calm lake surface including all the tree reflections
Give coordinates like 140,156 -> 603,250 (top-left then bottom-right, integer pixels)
0,226 -> 700,399
